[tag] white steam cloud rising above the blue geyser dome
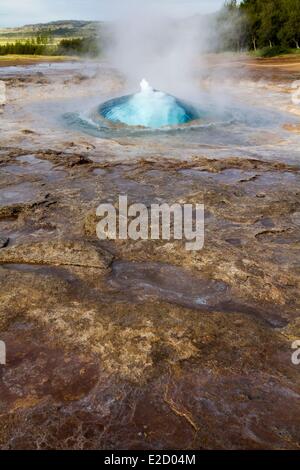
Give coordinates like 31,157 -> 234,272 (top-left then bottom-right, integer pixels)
107,0 -> 210,97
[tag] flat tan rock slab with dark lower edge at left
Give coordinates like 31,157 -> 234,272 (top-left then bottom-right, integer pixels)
0,240 -> 112,271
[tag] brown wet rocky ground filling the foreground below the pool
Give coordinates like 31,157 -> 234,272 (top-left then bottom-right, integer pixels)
0,57 -> 300,449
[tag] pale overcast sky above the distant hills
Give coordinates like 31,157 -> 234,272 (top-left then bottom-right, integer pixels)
0,0 -> 224,27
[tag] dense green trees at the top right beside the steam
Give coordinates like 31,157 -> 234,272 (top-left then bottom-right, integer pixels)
217,0 -> 300,52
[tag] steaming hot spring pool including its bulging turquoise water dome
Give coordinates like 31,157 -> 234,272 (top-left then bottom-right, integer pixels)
61,76 -> 299,149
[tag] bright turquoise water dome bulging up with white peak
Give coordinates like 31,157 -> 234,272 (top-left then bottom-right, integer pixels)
99,79 -> 199,129
